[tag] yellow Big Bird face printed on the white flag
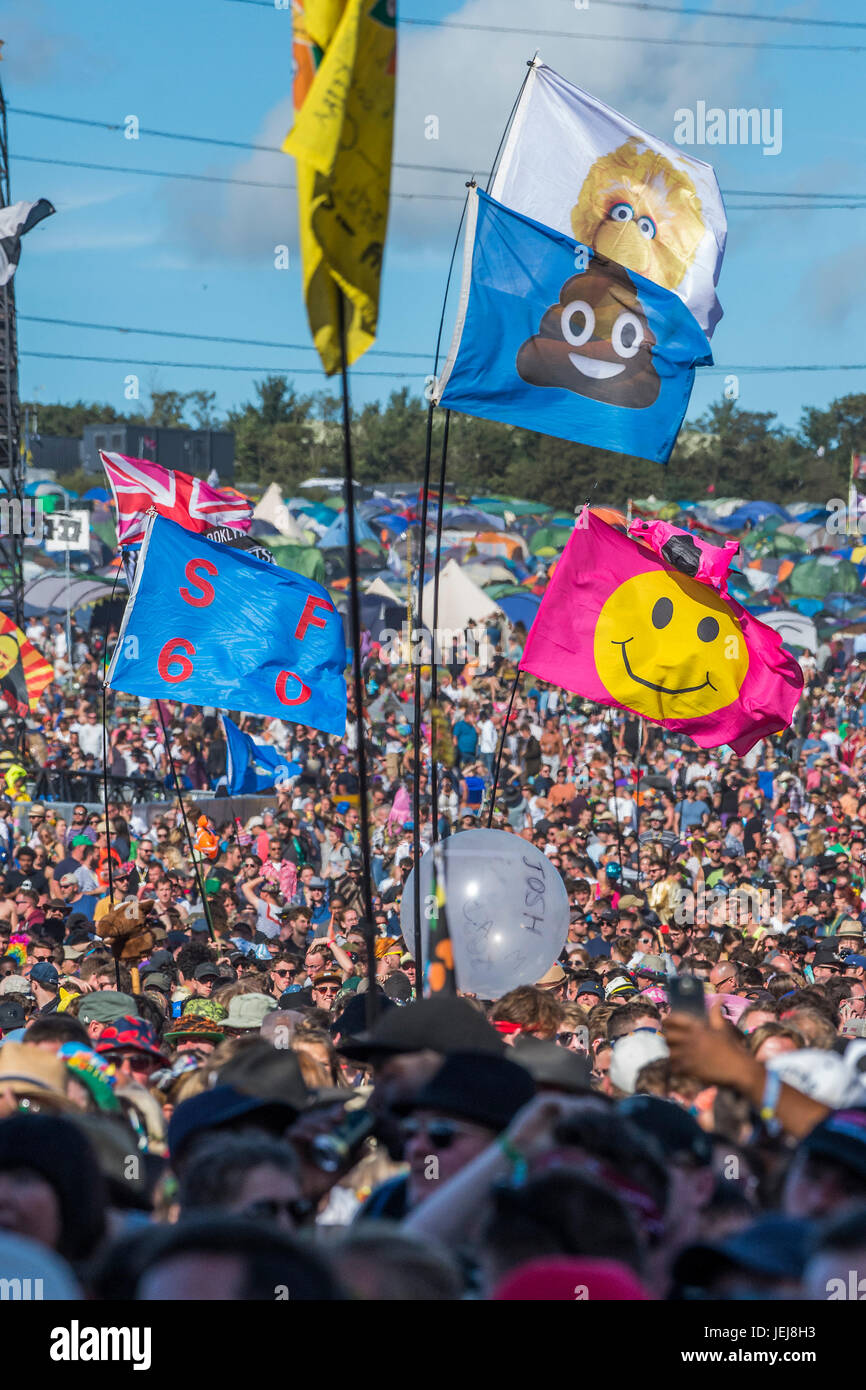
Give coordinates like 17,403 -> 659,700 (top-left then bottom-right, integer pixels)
571,138 -> 705,291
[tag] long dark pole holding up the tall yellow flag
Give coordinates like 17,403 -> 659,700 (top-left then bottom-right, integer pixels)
336,286 -> 378,1027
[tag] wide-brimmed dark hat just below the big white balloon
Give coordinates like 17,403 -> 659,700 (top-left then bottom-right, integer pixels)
338,997 -> 505,1062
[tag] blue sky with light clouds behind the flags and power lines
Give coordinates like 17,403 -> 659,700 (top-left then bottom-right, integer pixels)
6,0 -> 866,444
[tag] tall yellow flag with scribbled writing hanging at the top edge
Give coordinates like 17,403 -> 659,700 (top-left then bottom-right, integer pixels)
282,0 -> 396,375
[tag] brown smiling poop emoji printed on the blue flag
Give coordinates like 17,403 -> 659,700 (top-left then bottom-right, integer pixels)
517,259 -> 662,410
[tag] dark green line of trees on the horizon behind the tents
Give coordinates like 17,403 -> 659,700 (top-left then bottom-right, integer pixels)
31,377 -> 866,512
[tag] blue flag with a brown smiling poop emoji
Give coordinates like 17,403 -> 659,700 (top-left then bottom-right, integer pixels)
434,189 -> 713,463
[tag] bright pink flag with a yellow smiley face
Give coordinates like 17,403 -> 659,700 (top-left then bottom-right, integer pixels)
520,509 -> 803,755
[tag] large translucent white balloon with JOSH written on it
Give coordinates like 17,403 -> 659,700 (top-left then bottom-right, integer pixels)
400,830 -> 569,999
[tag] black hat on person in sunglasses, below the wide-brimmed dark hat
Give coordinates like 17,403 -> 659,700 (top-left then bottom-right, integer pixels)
396,1045 -> 535,1133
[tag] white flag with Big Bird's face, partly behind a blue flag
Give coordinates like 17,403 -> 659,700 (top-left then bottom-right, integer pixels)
491,63 -> 727,336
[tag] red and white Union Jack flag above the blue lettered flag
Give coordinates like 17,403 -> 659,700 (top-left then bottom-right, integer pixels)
100,449 -> 253,545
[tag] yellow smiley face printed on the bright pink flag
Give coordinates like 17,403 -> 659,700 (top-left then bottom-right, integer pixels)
594,570 -> 749,720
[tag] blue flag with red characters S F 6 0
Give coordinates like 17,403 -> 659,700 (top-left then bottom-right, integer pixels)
106,516 -> 346,734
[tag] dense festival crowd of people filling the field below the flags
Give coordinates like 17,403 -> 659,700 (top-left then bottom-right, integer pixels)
0,608 -> 866,1301
